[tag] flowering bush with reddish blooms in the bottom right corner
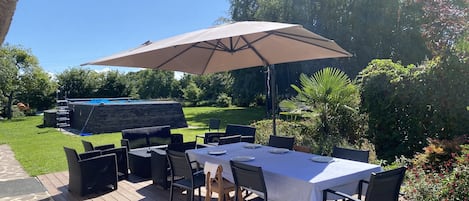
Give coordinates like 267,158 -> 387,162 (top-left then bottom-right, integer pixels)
398,138 -> 469,201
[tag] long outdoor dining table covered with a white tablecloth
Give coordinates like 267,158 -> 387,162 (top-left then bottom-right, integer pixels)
187,142 -> 382,201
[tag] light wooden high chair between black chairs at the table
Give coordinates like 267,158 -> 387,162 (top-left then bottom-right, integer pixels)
204,162 -> 235,201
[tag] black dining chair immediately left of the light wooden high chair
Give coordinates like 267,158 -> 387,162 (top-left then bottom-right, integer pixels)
166,150 -> 205,201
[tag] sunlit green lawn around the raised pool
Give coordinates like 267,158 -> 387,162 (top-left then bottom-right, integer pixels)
0,107 -> 265,176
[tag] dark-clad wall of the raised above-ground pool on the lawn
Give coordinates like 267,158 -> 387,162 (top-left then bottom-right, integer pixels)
69,101 -> 187,133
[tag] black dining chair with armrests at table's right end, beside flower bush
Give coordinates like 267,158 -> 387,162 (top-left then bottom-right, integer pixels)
322,167 -> 406,201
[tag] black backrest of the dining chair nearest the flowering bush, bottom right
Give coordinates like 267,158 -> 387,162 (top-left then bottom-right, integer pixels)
365,167 -> 406,201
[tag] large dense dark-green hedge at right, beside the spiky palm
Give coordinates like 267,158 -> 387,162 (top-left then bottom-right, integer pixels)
359,57 -> 469,160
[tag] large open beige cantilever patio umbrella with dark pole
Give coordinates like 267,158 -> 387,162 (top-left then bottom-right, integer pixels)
82,21 -> 351,135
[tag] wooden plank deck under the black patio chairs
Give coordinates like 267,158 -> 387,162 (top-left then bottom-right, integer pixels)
37,171 -> 205,201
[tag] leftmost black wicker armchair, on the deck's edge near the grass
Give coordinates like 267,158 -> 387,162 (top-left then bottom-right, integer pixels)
64,147 -> 117,196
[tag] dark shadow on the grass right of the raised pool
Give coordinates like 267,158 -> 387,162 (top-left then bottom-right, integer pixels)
186,107 -> 265,128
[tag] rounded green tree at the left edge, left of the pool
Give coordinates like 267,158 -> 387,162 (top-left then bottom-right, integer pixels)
0,45 -> 54,119
